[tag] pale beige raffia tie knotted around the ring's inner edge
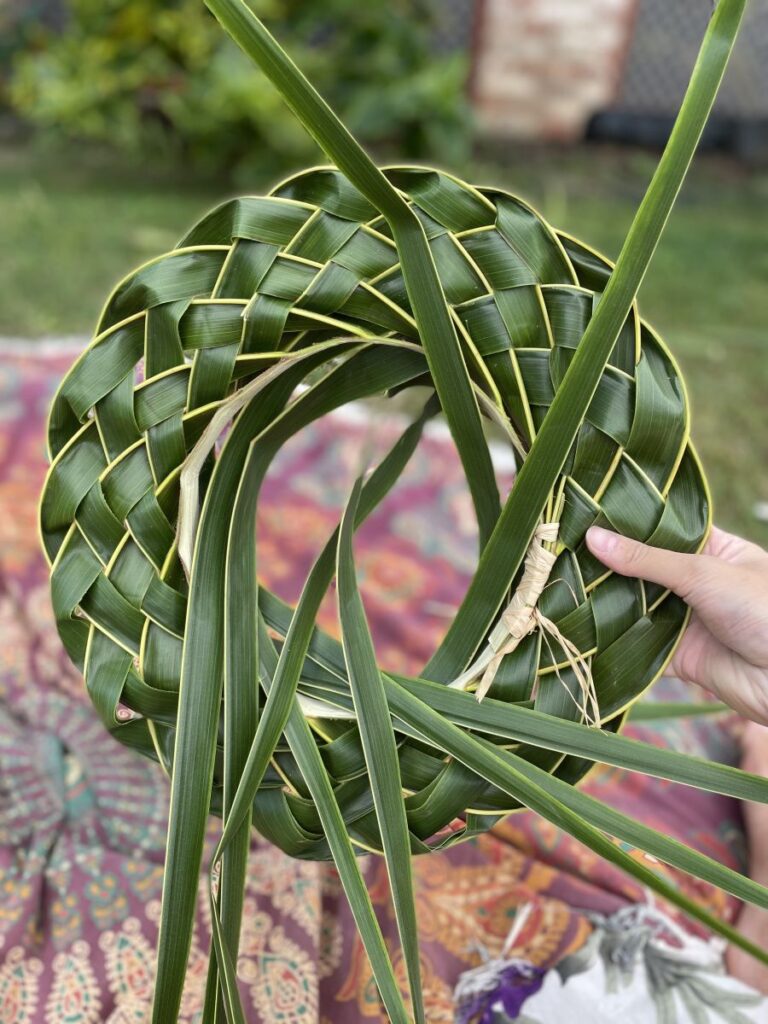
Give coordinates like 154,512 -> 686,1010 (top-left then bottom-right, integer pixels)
449,522 -> 600,726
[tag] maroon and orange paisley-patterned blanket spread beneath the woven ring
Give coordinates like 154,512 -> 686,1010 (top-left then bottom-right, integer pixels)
0,349 -> 744,1024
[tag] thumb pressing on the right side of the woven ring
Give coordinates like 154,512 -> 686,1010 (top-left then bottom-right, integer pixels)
587,526 -> 701,597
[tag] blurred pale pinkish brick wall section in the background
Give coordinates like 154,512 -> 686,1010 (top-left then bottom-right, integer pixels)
472,0 -> 637,141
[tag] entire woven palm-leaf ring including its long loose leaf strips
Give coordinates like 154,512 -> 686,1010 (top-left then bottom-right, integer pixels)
40,0 -> 768,1022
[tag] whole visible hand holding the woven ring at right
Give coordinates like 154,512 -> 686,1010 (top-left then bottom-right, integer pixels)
587,526 -> 768,725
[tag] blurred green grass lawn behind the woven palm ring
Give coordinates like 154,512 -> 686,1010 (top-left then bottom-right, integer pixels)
0,148 -> 768,545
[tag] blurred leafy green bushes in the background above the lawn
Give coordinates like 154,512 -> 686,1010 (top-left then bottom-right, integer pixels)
7,0 -> 470,179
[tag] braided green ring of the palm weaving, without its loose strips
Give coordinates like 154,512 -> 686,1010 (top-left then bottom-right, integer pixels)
41,167 -> 710,859
